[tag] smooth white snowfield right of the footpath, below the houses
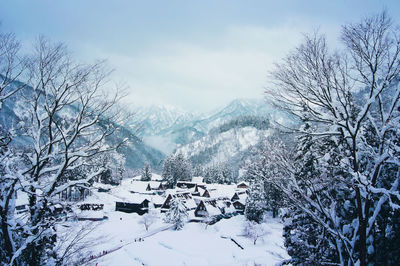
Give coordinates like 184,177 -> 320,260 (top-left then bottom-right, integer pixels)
93,215 -> 288,266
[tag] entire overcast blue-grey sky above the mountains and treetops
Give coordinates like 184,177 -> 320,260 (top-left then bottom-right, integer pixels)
0,0 -> 400,111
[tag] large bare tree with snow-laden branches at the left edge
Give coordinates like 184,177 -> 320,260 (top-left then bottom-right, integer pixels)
0,38 -> 126,265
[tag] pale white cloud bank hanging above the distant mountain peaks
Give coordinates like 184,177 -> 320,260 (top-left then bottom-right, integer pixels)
103,25 -> 310,111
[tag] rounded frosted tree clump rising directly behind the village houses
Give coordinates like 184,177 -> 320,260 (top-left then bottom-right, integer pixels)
162,153 -> 192,187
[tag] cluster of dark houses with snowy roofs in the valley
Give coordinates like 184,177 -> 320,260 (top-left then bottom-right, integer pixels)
115,177 -> 248,221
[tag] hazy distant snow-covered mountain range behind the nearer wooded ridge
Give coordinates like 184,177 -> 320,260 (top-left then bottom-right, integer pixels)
132,99 -> 279,154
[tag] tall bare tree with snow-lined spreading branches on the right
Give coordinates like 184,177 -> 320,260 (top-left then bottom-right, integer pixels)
266,12 -> 400,265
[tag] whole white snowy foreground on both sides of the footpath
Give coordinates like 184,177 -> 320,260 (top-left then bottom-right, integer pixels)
59,182 -> 288,266
